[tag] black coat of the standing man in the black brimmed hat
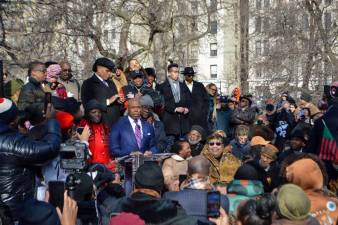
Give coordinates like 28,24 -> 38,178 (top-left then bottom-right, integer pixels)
186,81 -> 209,131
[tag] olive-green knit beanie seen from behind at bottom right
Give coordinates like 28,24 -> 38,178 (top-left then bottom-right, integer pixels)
277,184 -> 311,221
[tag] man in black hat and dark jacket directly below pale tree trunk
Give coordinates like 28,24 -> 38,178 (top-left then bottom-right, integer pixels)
231,95 -> 256,126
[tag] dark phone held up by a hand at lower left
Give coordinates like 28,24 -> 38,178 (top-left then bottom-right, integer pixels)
48,181 -> 65,210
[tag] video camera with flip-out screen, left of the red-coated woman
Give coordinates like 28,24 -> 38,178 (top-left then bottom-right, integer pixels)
60,141 -> 89,171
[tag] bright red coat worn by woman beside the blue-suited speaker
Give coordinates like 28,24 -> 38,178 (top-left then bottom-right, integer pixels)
78,120 -> 115,171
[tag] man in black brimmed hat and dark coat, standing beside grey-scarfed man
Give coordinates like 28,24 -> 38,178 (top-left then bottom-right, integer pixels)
182,67 -> 209,130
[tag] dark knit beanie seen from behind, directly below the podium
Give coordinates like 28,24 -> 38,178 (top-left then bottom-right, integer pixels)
135,162 -> 164,193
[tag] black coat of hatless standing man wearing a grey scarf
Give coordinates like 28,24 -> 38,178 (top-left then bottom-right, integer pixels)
159,80 -> 191,136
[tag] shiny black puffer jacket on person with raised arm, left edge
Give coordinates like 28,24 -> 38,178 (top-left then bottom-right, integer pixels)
0,120 -> 61,218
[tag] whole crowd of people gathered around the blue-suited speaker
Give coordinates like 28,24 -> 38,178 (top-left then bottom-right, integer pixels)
0,58 -> 338,225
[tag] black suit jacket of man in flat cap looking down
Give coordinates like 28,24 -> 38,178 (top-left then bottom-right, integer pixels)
81,74 -> 121,128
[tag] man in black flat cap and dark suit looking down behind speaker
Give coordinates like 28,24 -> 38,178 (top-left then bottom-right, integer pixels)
81,58 -> 122,128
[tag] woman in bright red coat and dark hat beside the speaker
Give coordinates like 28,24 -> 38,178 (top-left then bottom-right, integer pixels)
78,99 -> 115,172
